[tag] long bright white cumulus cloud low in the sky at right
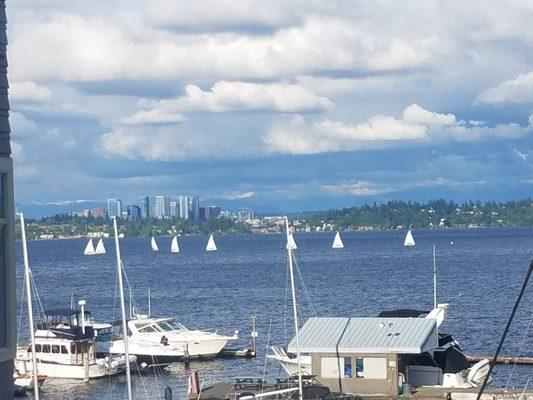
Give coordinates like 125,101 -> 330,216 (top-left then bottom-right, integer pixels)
263,104 -> 533,154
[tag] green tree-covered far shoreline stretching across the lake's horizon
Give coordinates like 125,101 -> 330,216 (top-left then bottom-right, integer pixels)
16,199 -> 533,239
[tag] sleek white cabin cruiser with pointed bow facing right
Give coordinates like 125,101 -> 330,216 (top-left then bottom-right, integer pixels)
95,315 -> 238,365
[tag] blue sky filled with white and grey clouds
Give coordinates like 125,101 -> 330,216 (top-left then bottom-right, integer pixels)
7,0 -> 533,212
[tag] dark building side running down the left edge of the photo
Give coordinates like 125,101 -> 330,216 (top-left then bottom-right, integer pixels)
0,0 -> 17,400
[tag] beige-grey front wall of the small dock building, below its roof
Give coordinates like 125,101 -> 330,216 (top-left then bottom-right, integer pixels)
311,353 -> 398,396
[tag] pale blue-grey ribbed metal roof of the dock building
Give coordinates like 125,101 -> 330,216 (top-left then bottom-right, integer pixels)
288,317 -> 439,354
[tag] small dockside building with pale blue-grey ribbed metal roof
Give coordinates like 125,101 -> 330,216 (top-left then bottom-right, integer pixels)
288,317 -> 439,396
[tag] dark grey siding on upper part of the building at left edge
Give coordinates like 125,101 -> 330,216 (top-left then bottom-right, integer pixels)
0,0 -> 11,156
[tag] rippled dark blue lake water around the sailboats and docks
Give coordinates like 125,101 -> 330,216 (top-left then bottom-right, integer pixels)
14,228 -> 533,400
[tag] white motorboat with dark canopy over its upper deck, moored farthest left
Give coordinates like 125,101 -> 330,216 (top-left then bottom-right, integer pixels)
15,308 -> 136,380
